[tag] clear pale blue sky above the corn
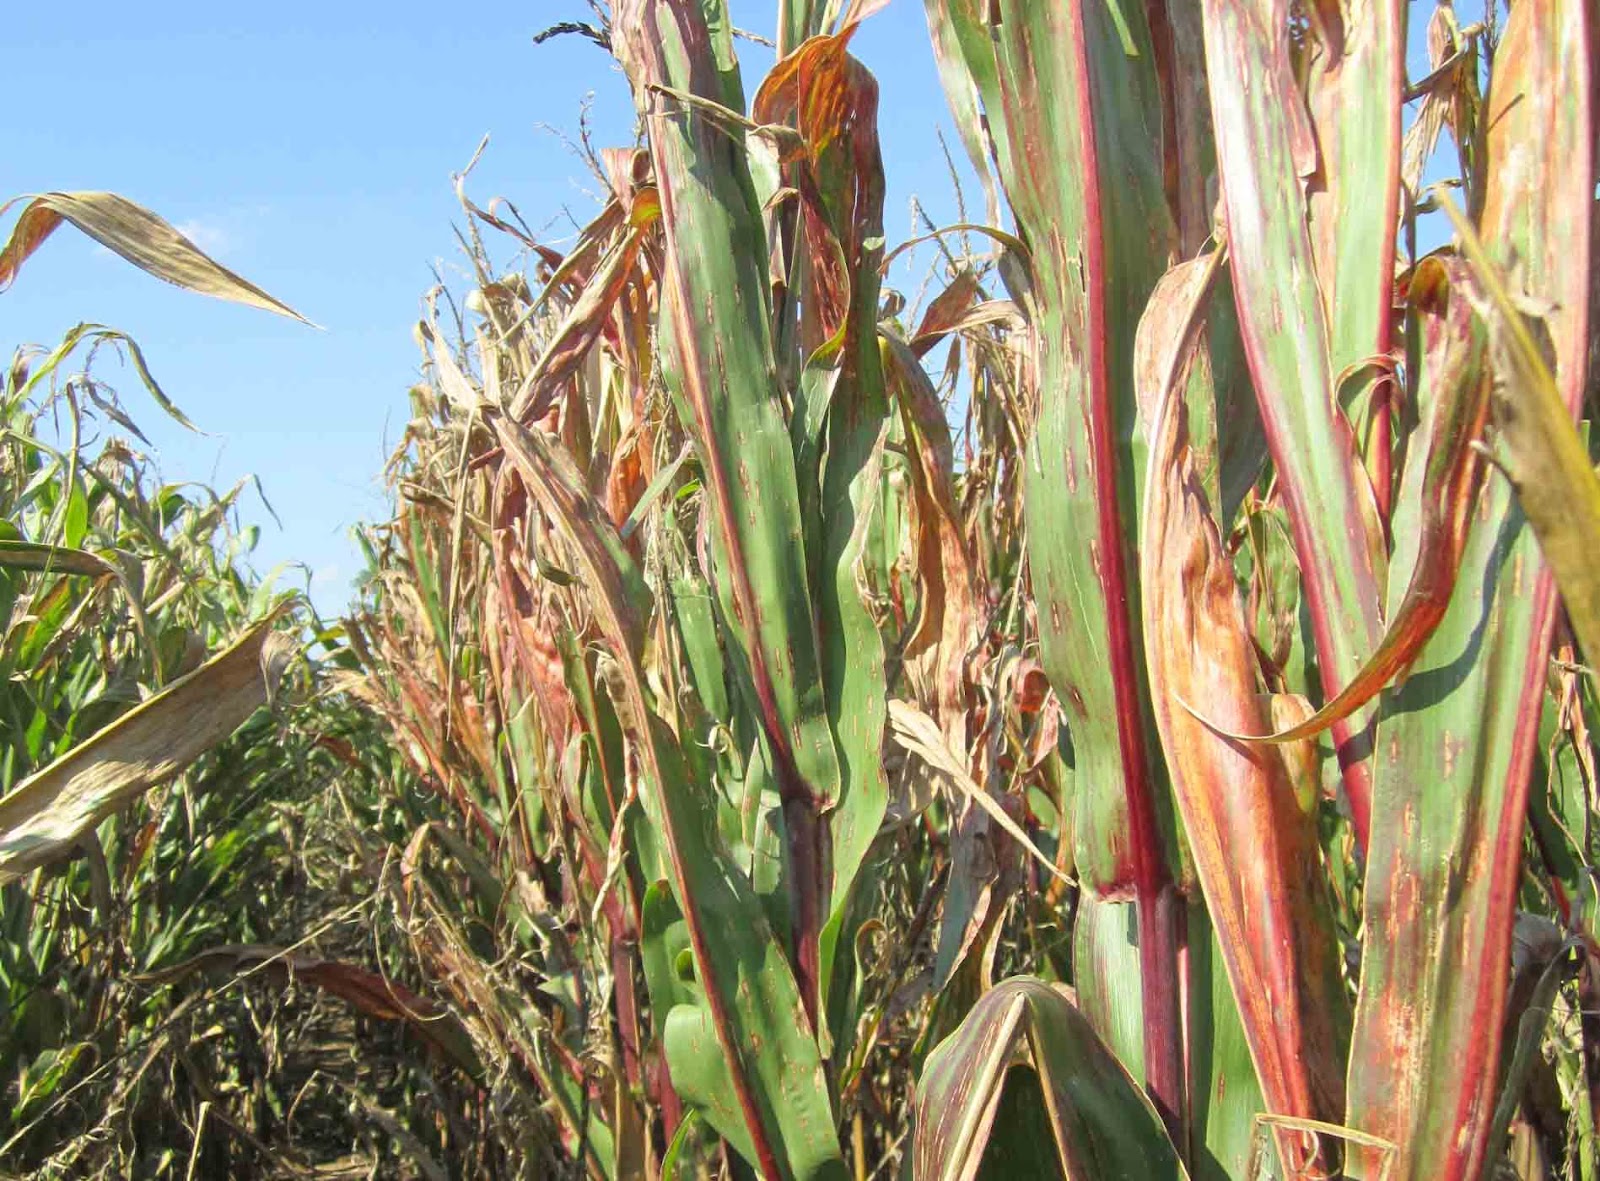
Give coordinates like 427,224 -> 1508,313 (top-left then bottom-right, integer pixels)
0,0 -> 1452,613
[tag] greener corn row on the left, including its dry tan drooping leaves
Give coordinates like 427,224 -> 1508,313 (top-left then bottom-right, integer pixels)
0,192 -> 477,1178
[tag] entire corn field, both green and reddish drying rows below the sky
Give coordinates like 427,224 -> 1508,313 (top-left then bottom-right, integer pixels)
0,0 -> 1600,1181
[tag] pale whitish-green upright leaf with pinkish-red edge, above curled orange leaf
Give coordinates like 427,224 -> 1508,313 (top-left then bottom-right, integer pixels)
1203,0 -> 1392,839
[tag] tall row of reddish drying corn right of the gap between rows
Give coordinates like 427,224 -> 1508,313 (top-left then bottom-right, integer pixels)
350,0 -> 1600,1179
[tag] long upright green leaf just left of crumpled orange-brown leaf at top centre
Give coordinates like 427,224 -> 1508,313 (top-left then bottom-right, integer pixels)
614,0 -> 840,1019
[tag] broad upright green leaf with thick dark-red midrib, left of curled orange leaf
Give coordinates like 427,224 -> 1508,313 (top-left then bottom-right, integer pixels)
930,0 -> 1182,1127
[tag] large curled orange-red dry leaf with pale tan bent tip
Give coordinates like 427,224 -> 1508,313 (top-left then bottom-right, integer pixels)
1136,248 -> 1349,1175
